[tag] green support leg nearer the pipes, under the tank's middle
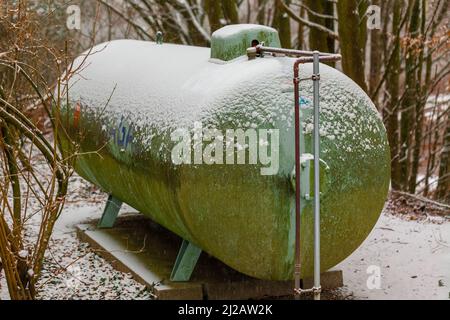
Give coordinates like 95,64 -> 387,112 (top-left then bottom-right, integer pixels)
170,240 -> 202,281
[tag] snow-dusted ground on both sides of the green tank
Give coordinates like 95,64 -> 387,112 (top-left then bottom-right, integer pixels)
0,169 -> 450,299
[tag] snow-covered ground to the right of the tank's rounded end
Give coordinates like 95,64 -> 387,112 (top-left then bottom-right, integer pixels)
336,212 -> 450,299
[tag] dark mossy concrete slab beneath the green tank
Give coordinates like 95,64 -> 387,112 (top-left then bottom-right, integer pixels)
77,214 -> 343,300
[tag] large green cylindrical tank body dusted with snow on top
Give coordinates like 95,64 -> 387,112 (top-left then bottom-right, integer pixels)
61,24 -> 390,280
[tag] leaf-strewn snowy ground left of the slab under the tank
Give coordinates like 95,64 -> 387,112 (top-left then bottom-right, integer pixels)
38,206 -> 151,299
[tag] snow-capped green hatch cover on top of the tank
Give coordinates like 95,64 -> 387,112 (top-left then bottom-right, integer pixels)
211,24 -> 281,61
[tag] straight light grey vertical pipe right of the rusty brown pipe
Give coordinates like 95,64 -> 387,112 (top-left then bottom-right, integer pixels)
313,51 -> 320,300
